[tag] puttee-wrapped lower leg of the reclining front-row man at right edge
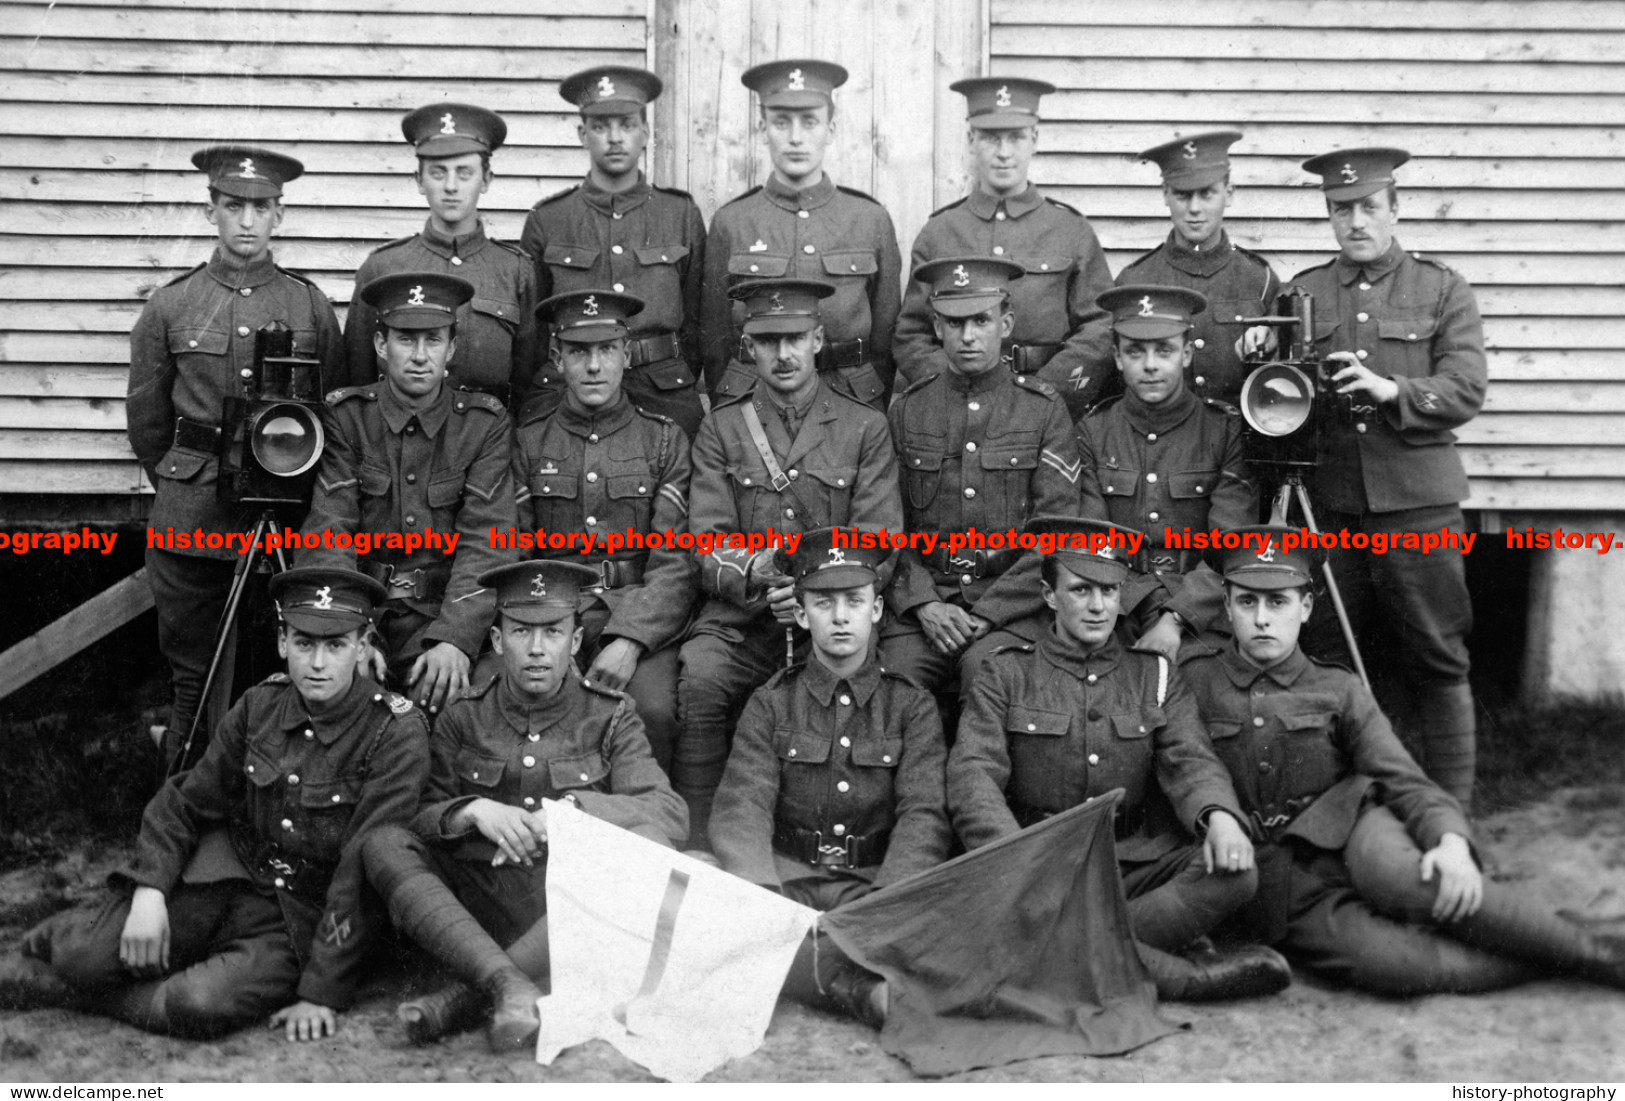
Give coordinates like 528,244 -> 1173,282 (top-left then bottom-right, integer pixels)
1438,880 -> 1625,989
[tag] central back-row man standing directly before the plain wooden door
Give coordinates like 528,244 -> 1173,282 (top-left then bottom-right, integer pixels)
700,60 -> 902,412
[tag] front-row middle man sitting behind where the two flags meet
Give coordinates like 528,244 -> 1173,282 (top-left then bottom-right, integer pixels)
710,528 -> 951,1028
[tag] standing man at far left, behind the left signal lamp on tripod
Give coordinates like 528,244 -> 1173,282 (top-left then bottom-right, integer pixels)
127,145 -> 345,757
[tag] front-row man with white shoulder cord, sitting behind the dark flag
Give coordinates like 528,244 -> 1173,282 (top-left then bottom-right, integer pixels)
947,516 -> 1292,1000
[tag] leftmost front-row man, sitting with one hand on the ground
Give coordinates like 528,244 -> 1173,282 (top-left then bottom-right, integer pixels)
0,570 -> 429,1039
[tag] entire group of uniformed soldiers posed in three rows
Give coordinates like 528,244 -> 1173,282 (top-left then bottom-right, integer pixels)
0,60 -> 1625,1049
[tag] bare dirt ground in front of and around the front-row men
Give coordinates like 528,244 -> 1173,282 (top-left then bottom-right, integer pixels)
0,786 -> 1625,1083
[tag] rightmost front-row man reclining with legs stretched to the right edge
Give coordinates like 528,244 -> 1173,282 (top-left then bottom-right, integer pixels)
1183,528 -> 1625,995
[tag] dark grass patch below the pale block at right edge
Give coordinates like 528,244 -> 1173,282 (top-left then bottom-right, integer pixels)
1477,698 -> 1625,812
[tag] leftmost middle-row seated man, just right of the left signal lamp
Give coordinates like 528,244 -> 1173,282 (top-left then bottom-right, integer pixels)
299,271 -> 515,713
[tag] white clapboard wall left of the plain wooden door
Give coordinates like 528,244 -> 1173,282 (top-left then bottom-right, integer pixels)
0,0 -> 650,500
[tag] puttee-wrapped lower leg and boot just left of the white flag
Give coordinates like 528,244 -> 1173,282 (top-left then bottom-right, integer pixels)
377,870 -> 541,1054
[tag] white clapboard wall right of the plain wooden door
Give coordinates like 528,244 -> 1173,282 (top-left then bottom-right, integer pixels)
990,0 -> 1625,512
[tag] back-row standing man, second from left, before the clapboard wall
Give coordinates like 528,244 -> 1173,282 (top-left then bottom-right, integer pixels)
338,104 -> 538,409
